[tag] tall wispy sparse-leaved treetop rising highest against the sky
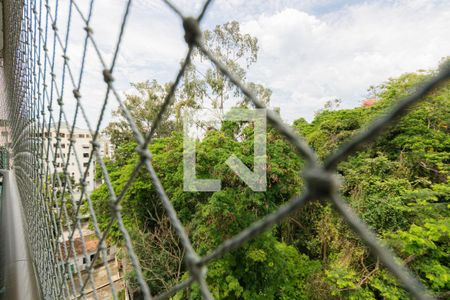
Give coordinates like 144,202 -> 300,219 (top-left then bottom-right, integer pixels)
178,21 -> 264,110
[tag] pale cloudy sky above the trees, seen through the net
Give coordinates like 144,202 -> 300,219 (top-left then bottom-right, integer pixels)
48,0 -> 450,127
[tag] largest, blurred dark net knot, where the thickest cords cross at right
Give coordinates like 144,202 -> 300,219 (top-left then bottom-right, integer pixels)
303,168 -> 339,198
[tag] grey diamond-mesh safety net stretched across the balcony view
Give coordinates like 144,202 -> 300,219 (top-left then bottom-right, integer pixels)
2,0 -> 450,299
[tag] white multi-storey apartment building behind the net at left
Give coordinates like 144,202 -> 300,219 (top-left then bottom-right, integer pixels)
44,123 -> 112,192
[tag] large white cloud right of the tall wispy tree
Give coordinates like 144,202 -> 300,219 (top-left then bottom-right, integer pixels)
242,1 -> 450,121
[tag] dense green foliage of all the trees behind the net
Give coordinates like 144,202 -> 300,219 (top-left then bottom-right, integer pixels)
91,23 -> 450,299
